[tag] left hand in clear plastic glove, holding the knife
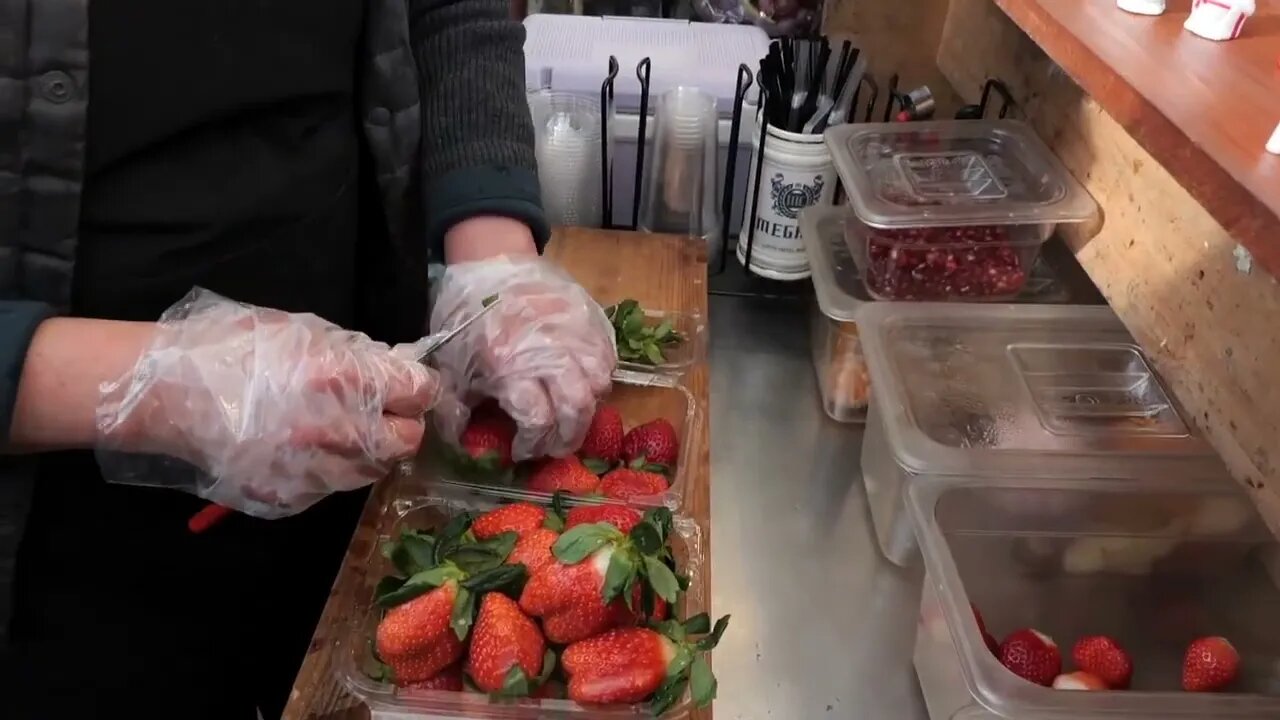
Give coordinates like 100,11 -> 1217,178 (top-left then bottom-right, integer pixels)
97,290 -> 439,518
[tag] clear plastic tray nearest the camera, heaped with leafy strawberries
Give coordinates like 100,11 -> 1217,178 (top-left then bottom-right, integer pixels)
337,495 -> 707,720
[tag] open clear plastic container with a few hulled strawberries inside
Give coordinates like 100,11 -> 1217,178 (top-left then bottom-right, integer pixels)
908,479 -> 1280,720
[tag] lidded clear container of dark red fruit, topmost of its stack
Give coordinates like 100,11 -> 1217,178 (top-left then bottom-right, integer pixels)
827,120 -> 1097,301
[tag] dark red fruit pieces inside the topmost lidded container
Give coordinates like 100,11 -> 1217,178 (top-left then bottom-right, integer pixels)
867,225 -> 1027,300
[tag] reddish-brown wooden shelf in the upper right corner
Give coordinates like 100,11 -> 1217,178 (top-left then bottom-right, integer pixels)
995,0 -> 1280,277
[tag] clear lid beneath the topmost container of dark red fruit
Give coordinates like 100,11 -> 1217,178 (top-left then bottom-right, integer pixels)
800,205 -> 1070,323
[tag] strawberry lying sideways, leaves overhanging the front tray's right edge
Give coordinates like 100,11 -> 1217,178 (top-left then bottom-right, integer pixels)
561,614 -> 728,716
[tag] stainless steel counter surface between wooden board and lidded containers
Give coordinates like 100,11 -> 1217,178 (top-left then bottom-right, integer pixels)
710,296 -> 928,720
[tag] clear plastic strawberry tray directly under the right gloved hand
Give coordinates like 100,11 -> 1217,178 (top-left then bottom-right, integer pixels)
408,370 -> 703,510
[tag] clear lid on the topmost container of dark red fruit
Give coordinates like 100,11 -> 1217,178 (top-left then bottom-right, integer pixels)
826,120 -> 1097,228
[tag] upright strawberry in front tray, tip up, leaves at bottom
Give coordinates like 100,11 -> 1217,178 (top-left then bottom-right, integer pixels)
467,592 -> 547,697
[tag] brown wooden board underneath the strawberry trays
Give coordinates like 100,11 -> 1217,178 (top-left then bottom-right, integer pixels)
283,228 -> 712,720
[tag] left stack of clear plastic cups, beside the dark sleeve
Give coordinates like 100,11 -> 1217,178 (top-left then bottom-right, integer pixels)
529,90 -> 604,227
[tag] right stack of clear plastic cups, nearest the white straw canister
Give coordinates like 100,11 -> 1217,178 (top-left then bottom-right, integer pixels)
640,87 -> 721,266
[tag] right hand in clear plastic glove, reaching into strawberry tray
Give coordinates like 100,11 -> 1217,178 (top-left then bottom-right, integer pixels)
431,258 -> 618,460
